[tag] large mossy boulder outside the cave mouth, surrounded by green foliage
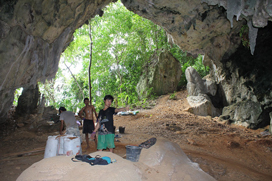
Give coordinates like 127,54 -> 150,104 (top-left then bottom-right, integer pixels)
136,52 -> 181,97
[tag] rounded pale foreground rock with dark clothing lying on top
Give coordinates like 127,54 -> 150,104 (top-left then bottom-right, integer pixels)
17,151 -> 141,181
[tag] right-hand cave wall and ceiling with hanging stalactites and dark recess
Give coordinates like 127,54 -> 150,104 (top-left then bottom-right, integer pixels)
122,0 -> 272,127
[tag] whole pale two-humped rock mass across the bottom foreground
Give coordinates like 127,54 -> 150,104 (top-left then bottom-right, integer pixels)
17,138 -> 215,181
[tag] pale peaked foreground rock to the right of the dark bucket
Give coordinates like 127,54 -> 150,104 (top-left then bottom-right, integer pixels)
139,138 -> 215,181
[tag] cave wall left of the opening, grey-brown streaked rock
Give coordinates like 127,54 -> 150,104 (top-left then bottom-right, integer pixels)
0,0 -> 112,121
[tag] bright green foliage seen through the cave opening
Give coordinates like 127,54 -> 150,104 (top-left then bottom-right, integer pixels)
36,1 -> 208,112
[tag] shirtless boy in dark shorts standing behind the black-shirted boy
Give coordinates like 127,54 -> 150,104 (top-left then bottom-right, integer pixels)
78,98 -> 97,149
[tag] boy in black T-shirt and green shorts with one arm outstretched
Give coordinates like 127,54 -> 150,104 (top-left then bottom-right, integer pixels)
91,95 -> 129,152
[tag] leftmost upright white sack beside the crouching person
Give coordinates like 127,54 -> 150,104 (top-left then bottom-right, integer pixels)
44,136 -> 58,158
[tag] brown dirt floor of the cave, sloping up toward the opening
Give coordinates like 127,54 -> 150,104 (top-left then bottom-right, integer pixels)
0,91 -> 272,181
